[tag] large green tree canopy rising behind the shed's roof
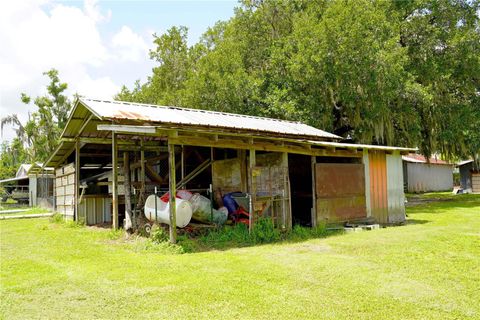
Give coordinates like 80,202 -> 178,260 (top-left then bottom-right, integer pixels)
116,0 -> 480,164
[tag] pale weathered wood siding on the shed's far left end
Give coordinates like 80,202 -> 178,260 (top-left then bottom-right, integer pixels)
55,163 -> 75,220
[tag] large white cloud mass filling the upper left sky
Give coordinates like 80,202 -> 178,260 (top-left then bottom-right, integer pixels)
0,0 -> 149,139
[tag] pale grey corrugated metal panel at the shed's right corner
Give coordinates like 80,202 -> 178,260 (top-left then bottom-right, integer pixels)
387,152 -> 405,223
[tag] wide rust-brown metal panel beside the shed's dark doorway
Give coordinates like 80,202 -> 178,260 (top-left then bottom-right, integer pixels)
315,163 -> 367,223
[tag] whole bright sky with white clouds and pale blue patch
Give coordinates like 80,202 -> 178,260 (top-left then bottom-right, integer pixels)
0,0 -> 238,141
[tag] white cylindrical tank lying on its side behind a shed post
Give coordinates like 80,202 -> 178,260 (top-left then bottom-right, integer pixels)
144,194 -> 192,228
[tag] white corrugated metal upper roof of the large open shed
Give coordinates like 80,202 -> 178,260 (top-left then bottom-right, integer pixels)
80,98 -> 342,140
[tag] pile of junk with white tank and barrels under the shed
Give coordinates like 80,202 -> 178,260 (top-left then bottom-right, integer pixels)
145,190 -> 250,228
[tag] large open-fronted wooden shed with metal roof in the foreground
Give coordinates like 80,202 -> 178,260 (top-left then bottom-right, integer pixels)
46,98 -> 414,241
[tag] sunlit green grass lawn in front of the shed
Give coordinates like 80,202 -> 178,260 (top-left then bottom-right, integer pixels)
0,195 -> 480,319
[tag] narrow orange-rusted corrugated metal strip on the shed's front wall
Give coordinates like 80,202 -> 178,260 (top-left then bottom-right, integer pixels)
368,150 -> 388,223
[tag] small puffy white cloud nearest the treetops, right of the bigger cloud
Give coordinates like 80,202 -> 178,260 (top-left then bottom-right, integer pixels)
112,26 -> 148,61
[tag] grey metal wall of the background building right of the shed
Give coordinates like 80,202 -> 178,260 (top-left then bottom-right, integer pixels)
407,162 -> 453,192
